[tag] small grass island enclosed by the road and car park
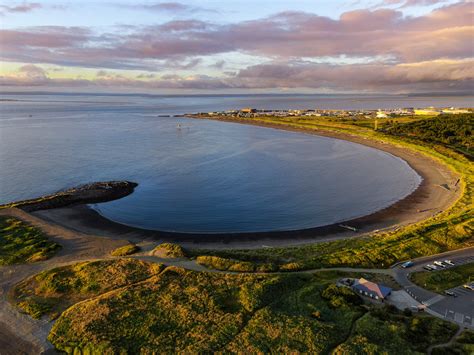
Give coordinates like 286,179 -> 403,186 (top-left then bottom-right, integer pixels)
411,263 -> 474,294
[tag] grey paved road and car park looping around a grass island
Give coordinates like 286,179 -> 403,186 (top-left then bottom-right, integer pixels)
393,248 -> 474,329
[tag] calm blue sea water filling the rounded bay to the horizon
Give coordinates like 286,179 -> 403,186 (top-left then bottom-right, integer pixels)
0,95 -> 461,232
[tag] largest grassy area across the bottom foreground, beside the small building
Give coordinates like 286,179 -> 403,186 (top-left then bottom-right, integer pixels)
44,260 -> 456,354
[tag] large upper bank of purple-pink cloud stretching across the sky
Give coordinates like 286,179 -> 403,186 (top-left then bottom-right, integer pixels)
0,3 -> 473,70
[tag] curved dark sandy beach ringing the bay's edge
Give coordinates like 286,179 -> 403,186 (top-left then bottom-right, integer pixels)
28,118 -> 459,248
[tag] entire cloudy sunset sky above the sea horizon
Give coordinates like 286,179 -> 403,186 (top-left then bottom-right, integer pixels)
0,0 -> 474,94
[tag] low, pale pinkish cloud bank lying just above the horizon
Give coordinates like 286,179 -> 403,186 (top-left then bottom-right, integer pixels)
0,59 -> 474,92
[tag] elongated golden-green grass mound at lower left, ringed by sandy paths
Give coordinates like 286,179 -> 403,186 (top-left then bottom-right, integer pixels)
10,259 -> 161,318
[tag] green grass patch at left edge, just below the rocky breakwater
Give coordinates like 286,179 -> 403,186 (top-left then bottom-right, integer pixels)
0,217 -> 61,265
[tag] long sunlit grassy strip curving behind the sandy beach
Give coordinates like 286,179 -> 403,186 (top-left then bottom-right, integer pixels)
188,115 -> 474,271
